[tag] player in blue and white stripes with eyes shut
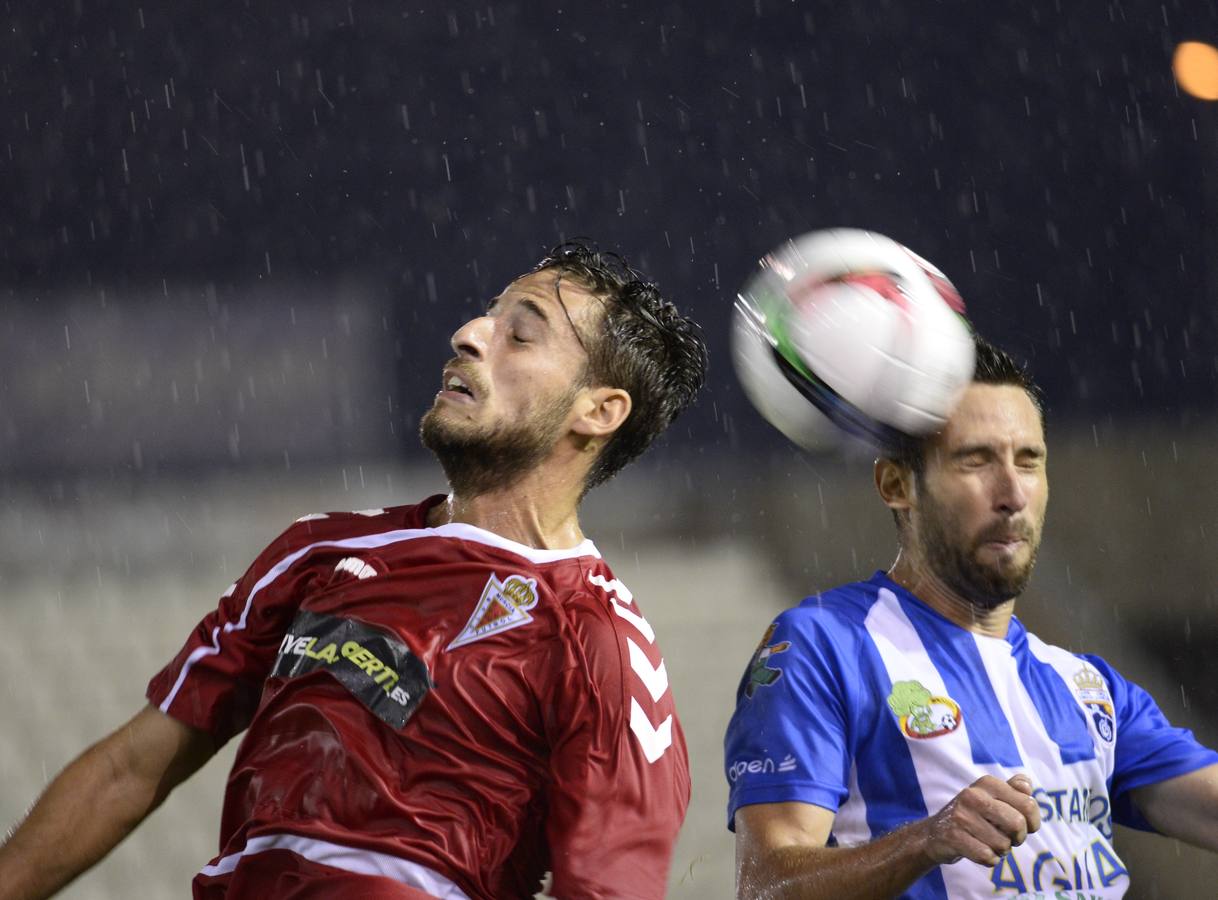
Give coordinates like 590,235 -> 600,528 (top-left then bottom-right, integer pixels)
726,341 -> 1218,900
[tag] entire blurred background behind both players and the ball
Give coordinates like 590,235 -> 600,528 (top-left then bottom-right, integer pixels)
0,0 -> 1218,900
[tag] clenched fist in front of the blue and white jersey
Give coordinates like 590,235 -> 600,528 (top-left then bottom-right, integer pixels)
926,775 -> 1040,866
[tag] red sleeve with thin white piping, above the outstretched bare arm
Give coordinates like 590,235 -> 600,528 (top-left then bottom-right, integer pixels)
146,518 -> 325,743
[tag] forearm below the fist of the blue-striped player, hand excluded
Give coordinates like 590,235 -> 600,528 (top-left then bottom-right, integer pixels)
737,822 -> 934,900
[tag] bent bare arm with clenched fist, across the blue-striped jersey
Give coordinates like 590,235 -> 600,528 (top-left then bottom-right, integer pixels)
736,776 -> 1040,900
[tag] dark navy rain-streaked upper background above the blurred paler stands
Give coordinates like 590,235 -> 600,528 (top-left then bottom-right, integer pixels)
0,0 -> 1218,469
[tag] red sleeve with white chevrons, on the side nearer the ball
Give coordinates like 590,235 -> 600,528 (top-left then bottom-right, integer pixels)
547,581 -> 689,900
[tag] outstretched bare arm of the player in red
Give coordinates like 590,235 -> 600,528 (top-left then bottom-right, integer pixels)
0,706 -> 216,900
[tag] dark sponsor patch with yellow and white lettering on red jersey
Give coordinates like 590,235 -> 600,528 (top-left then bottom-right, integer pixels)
270,610 -> 434,728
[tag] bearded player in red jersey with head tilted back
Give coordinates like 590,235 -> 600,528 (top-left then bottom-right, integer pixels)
0,244 -> 705,900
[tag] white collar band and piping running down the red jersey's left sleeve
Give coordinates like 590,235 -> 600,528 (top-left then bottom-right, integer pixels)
160,522 -> 600,712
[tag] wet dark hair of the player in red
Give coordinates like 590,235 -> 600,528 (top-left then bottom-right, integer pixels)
533,239 -> 706,493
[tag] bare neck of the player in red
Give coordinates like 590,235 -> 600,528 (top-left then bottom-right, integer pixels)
428,466 -> 583,549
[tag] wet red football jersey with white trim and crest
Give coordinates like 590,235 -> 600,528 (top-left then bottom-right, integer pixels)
147,497 -> 689,900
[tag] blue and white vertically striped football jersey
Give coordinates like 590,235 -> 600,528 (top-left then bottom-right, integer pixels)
725,572 -> 1218,900
